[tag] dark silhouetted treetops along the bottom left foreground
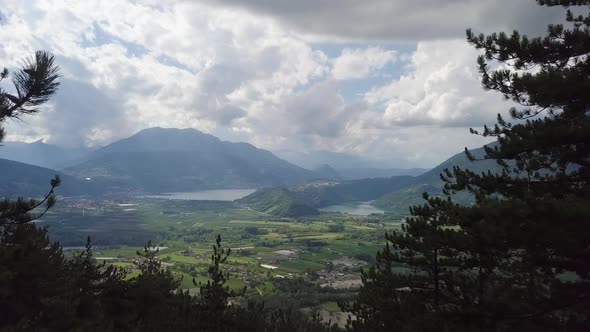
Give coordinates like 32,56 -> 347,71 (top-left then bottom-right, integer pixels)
0,223 -> 344,331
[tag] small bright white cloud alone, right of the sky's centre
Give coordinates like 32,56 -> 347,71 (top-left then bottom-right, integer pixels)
332,47 -> 397,80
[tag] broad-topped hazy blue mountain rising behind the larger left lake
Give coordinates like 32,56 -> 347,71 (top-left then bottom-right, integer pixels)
64,128 -> 317,192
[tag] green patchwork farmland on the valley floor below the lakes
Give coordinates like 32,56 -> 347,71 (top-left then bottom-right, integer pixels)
40,198 -> 408,317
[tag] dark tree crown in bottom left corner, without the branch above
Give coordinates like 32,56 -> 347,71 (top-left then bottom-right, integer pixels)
0,224 -> 69,330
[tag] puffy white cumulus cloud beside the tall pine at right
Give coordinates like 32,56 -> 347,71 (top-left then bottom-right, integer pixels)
365,40 -> 508,127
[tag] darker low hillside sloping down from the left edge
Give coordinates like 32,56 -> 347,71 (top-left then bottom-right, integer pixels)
0,159 -> 100,198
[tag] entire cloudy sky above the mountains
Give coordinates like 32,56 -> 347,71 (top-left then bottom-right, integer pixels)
0,0 -> 564,167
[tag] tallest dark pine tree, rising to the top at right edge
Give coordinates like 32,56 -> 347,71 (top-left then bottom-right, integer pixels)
445,0 -> 590,330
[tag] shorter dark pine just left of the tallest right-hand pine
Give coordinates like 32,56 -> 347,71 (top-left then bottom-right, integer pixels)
340,194 -> 466,331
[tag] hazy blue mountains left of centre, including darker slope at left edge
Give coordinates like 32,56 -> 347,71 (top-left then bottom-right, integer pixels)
0,128 -> 338,196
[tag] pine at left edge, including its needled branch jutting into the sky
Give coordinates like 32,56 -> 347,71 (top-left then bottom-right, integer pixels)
0,51 -> 67,330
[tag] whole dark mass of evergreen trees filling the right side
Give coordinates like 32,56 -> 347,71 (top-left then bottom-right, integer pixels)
343,0 -> 590,331
